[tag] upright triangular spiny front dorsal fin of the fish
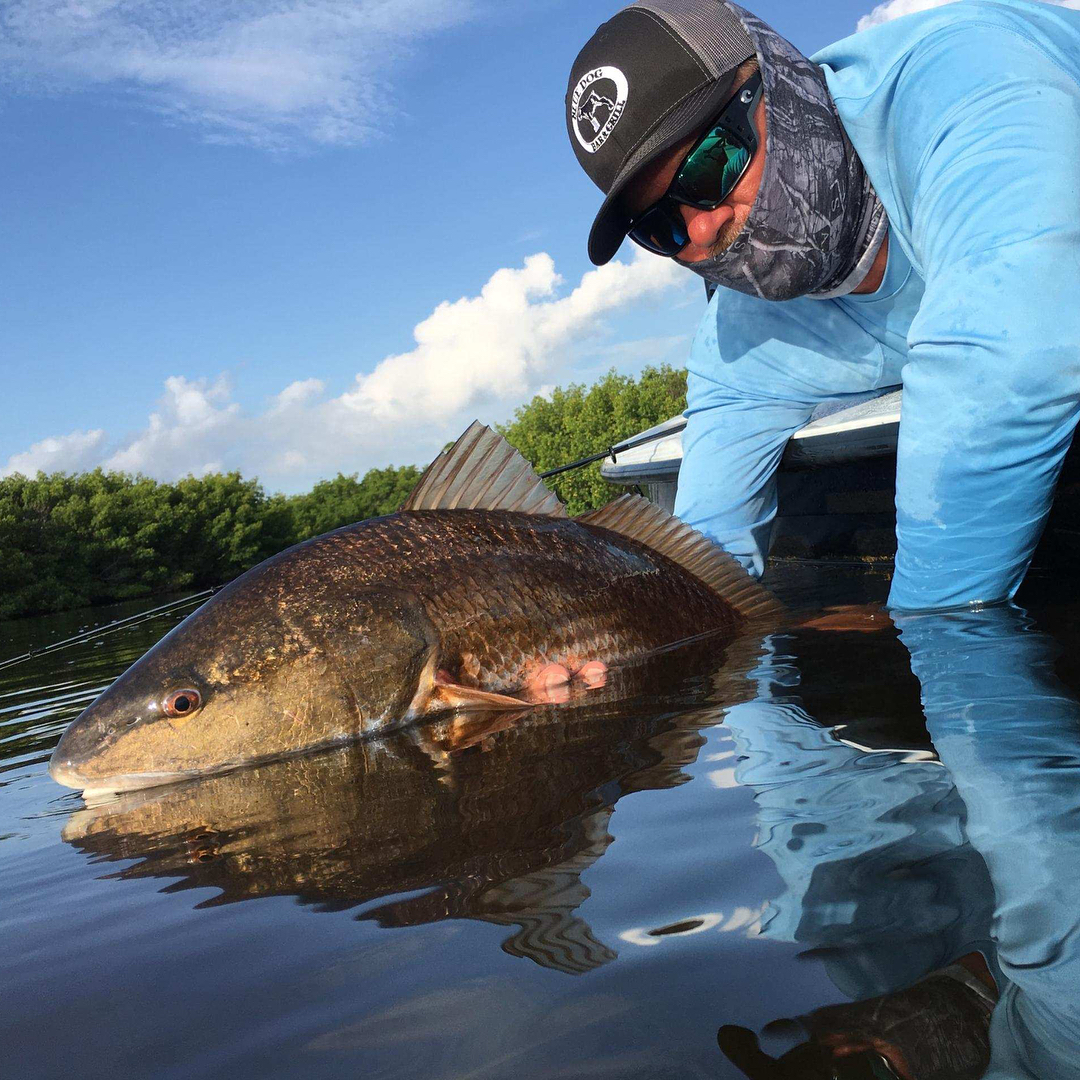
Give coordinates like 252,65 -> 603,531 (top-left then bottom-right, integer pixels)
402,421 -> 567,517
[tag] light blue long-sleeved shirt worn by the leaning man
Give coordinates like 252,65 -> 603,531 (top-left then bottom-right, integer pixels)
676,0 -> 1080,609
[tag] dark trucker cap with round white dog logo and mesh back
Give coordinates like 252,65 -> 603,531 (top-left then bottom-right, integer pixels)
566,0 -> 756,266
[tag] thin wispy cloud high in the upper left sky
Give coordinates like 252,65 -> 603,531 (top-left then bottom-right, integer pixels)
0,0 -> 486,149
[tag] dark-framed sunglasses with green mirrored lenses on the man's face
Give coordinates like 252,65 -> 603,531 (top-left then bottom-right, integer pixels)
629,71 -> 764,258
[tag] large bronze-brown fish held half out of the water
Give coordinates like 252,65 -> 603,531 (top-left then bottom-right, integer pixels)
50,423 -> 779,792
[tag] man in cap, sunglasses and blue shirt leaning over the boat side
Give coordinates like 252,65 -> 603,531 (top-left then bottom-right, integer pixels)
567,0 -> 1080,609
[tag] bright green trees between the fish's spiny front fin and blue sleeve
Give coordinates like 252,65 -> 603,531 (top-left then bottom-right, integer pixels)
499,364 -> 686,514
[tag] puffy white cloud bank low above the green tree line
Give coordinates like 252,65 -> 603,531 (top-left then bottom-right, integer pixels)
0,252 -> 699,489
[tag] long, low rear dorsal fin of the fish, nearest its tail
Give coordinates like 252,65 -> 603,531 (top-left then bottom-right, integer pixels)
575,495 -> 784,619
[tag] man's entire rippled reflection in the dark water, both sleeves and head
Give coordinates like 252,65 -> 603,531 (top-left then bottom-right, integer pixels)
718,605 -> 1080,1080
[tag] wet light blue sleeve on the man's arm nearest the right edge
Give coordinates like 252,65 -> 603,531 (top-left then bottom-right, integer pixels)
890,23 -> 1080,609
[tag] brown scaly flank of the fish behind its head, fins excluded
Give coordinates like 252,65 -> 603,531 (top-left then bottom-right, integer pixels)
297,510 -> 743,692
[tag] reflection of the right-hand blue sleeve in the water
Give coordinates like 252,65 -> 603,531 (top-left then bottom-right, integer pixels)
897,605 -> 1080,1080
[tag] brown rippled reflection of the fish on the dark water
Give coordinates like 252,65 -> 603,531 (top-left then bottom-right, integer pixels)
64,673 -> 759,974
